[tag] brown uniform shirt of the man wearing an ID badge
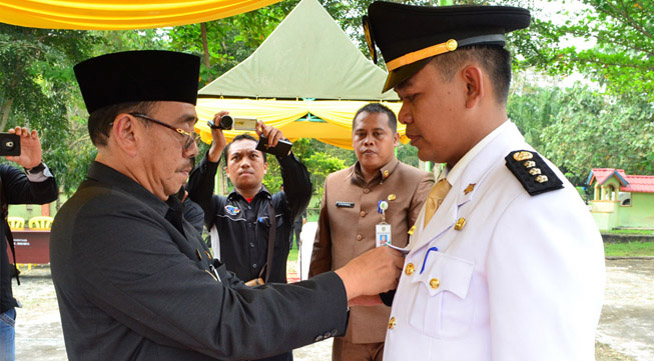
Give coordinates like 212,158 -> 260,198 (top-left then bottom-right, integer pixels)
309,158 -> 434,343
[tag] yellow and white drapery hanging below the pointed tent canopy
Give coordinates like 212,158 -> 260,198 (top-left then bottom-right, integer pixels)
195,98 -> 408,149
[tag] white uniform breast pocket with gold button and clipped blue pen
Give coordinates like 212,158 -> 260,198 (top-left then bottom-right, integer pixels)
409,252 -> 475,339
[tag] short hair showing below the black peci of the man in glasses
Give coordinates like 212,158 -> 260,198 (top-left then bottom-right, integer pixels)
88,101 -> 157,147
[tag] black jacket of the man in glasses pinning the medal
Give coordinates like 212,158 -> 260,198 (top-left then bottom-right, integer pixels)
50,162 -> 347,361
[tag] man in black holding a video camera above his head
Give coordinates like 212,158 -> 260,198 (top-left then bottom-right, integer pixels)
188,112 -> 311,361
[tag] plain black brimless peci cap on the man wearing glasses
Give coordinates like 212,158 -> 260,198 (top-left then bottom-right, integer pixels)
74,50 -> 200,114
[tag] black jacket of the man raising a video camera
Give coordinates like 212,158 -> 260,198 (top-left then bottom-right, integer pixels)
187,154 -> 311,283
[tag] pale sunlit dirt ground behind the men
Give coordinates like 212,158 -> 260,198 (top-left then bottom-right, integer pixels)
14,259 -> 654,361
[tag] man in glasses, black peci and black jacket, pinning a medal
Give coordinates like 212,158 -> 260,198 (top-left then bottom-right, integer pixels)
50,50 -> 403,361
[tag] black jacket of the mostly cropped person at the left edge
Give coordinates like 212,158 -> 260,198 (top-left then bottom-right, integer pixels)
0,164 -> 59,313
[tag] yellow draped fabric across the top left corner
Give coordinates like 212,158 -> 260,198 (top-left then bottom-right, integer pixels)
0,0 -> 286,30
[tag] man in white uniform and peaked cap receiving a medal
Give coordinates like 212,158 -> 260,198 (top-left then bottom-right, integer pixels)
364,2 -> 604,361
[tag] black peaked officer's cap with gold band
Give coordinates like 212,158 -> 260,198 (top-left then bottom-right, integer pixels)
363,1 -> 531,92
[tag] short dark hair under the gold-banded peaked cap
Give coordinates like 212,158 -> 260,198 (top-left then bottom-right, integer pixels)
429,45 -> 511,104
